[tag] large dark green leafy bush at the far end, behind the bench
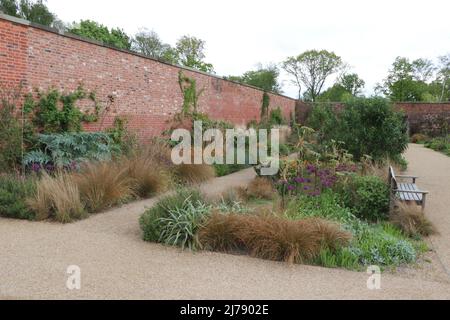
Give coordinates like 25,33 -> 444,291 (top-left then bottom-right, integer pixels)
309,98 -> 408,160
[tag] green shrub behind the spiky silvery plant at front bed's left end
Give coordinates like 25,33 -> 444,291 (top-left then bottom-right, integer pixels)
139,189 -> 206,242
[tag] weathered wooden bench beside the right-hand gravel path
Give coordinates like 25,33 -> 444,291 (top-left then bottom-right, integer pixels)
389,167 -> 428,210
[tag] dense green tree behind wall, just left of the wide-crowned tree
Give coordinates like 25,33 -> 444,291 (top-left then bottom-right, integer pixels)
227,64 -> 282,93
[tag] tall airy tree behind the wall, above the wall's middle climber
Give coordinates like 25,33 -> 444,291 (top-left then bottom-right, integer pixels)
173,36 -> 214,72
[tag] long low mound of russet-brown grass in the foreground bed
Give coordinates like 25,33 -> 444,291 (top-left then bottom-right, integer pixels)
199,213 -> 351,263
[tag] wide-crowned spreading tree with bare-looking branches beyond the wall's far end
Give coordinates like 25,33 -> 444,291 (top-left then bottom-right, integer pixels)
283,50 -> 343,101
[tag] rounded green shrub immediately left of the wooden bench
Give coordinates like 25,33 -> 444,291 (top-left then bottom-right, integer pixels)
338,176 -> 389,221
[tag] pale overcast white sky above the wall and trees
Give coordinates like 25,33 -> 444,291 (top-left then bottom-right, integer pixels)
47,0 -> 450,98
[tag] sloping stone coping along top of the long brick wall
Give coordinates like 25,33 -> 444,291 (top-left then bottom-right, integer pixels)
0,11 -> 297,101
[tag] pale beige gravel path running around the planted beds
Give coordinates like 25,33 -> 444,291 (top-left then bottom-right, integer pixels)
0,146 -> 450,299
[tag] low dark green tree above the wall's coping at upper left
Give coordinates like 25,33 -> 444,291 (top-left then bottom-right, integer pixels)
68,20 -> 131,50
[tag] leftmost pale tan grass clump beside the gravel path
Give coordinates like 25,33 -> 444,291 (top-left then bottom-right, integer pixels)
28,173 -> 87,223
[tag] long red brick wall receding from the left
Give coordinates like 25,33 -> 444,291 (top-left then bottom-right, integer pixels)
0,16 -> 295,137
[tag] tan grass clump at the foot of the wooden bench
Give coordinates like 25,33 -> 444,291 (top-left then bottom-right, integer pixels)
389,201 -> 437,237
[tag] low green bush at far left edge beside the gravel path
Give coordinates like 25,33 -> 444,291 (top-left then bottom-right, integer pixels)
0,175 -> 36,220
